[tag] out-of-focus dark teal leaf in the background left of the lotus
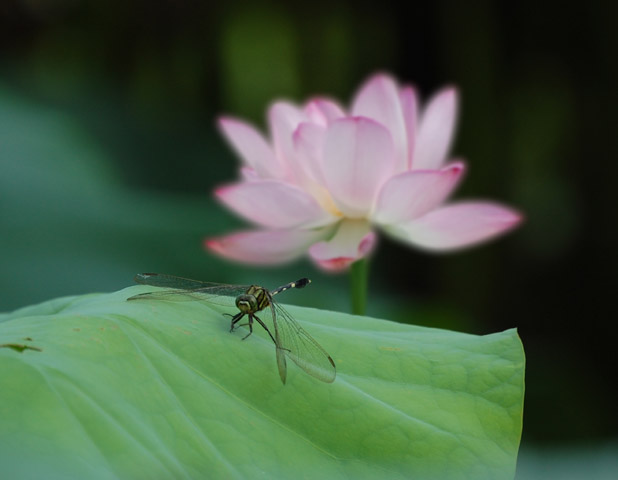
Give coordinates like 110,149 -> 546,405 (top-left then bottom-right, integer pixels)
0,83 -> 239,310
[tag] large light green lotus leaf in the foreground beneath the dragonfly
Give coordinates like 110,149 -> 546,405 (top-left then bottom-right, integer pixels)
0,287 -> 524,480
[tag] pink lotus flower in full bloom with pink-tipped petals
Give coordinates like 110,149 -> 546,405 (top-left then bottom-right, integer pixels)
205,74 -> 521,270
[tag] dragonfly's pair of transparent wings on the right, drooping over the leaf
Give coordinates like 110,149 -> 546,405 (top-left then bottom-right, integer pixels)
271,300 -> 337,383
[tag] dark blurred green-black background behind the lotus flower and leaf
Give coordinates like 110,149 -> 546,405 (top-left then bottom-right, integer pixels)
0,0 -> 618,478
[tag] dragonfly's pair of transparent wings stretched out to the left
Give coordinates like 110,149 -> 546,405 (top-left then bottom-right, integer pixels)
127,273 -> 249,306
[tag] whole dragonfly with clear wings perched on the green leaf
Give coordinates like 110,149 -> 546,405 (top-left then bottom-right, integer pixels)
127,273 -> 336,384
